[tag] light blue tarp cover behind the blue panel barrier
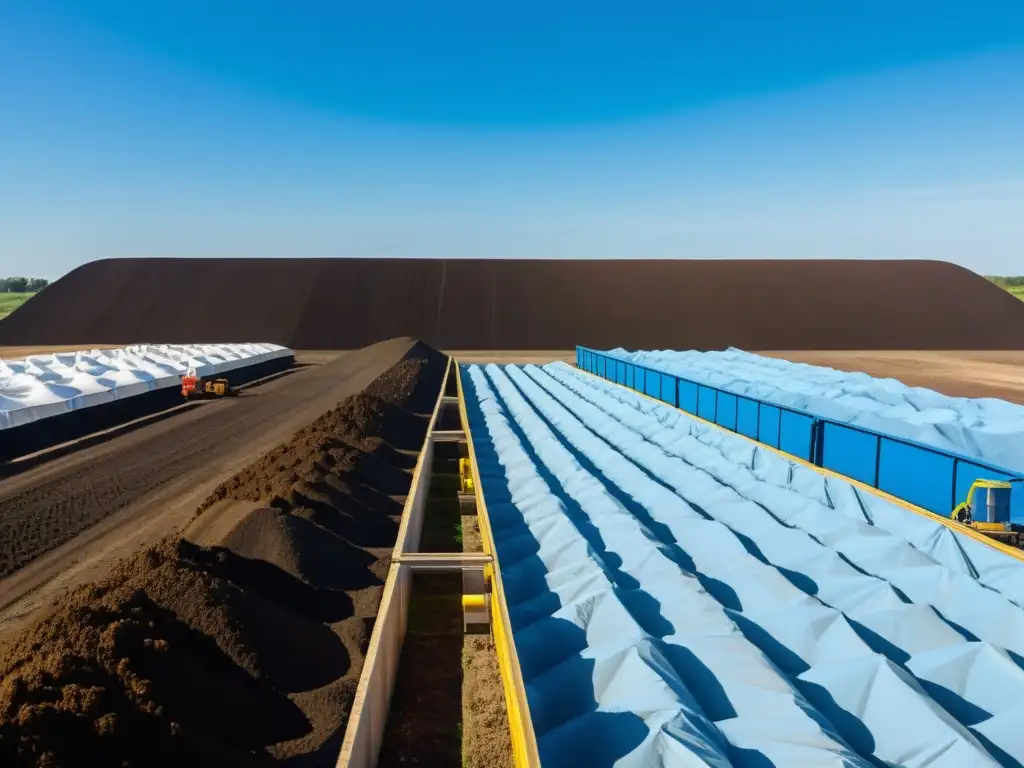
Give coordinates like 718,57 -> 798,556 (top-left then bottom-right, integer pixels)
608,349 -> 1024,471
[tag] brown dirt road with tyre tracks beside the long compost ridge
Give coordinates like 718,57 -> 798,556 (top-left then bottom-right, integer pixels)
0,339 -> 414,634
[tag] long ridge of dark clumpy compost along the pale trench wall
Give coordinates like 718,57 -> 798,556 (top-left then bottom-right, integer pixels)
0,345 -> 446,767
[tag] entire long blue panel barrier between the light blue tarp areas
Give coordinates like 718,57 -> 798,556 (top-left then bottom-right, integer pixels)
577,347 -> 1024,522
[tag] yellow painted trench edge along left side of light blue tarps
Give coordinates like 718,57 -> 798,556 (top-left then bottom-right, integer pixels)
455,359 -> 541,768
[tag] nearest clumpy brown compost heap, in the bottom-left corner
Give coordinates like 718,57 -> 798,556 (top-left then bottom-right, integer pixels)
0,544 -> 296,766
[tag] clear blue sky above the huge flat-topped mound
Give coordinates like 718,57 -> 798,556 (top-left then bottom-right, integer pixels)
0,0 -> 1024,278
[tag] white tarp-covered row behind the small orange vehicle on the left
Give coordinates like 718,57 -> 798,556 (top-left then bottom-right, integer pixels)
0,344 -> 292,429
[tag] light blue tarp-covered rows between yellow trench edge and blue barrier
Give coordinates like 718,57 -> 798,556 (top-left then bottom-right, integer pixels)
464,364 -> 1024,768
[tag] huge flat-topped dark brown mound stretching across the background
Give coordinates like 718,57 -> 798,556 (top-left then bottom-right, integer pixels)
0,259 -> 1024,350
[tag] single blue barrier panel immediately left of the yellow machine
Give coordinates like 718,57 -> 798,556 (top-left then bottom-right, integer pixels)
879,438 -> 953,515
